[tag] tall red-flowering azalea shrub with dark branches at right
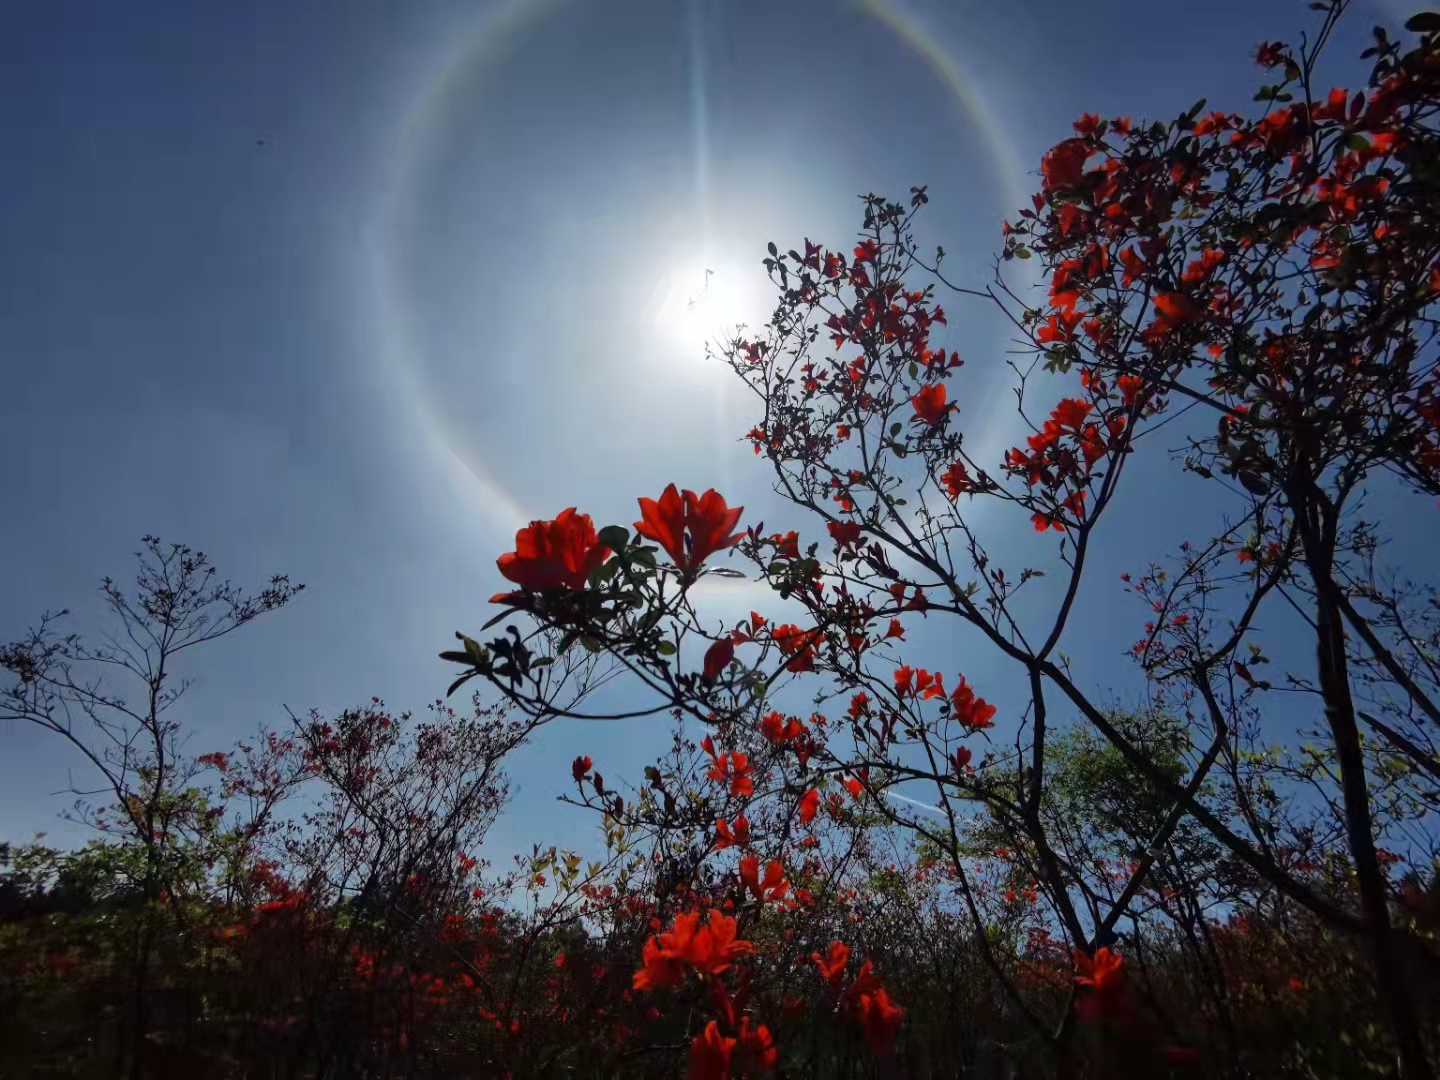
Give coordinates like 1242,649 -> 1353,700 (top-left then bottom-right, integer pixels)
437,4 -> 1440,1076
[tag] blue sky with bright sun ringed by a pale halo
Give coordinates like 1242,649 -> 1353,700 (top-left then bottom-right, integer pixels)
0,0 -> 1408,854
